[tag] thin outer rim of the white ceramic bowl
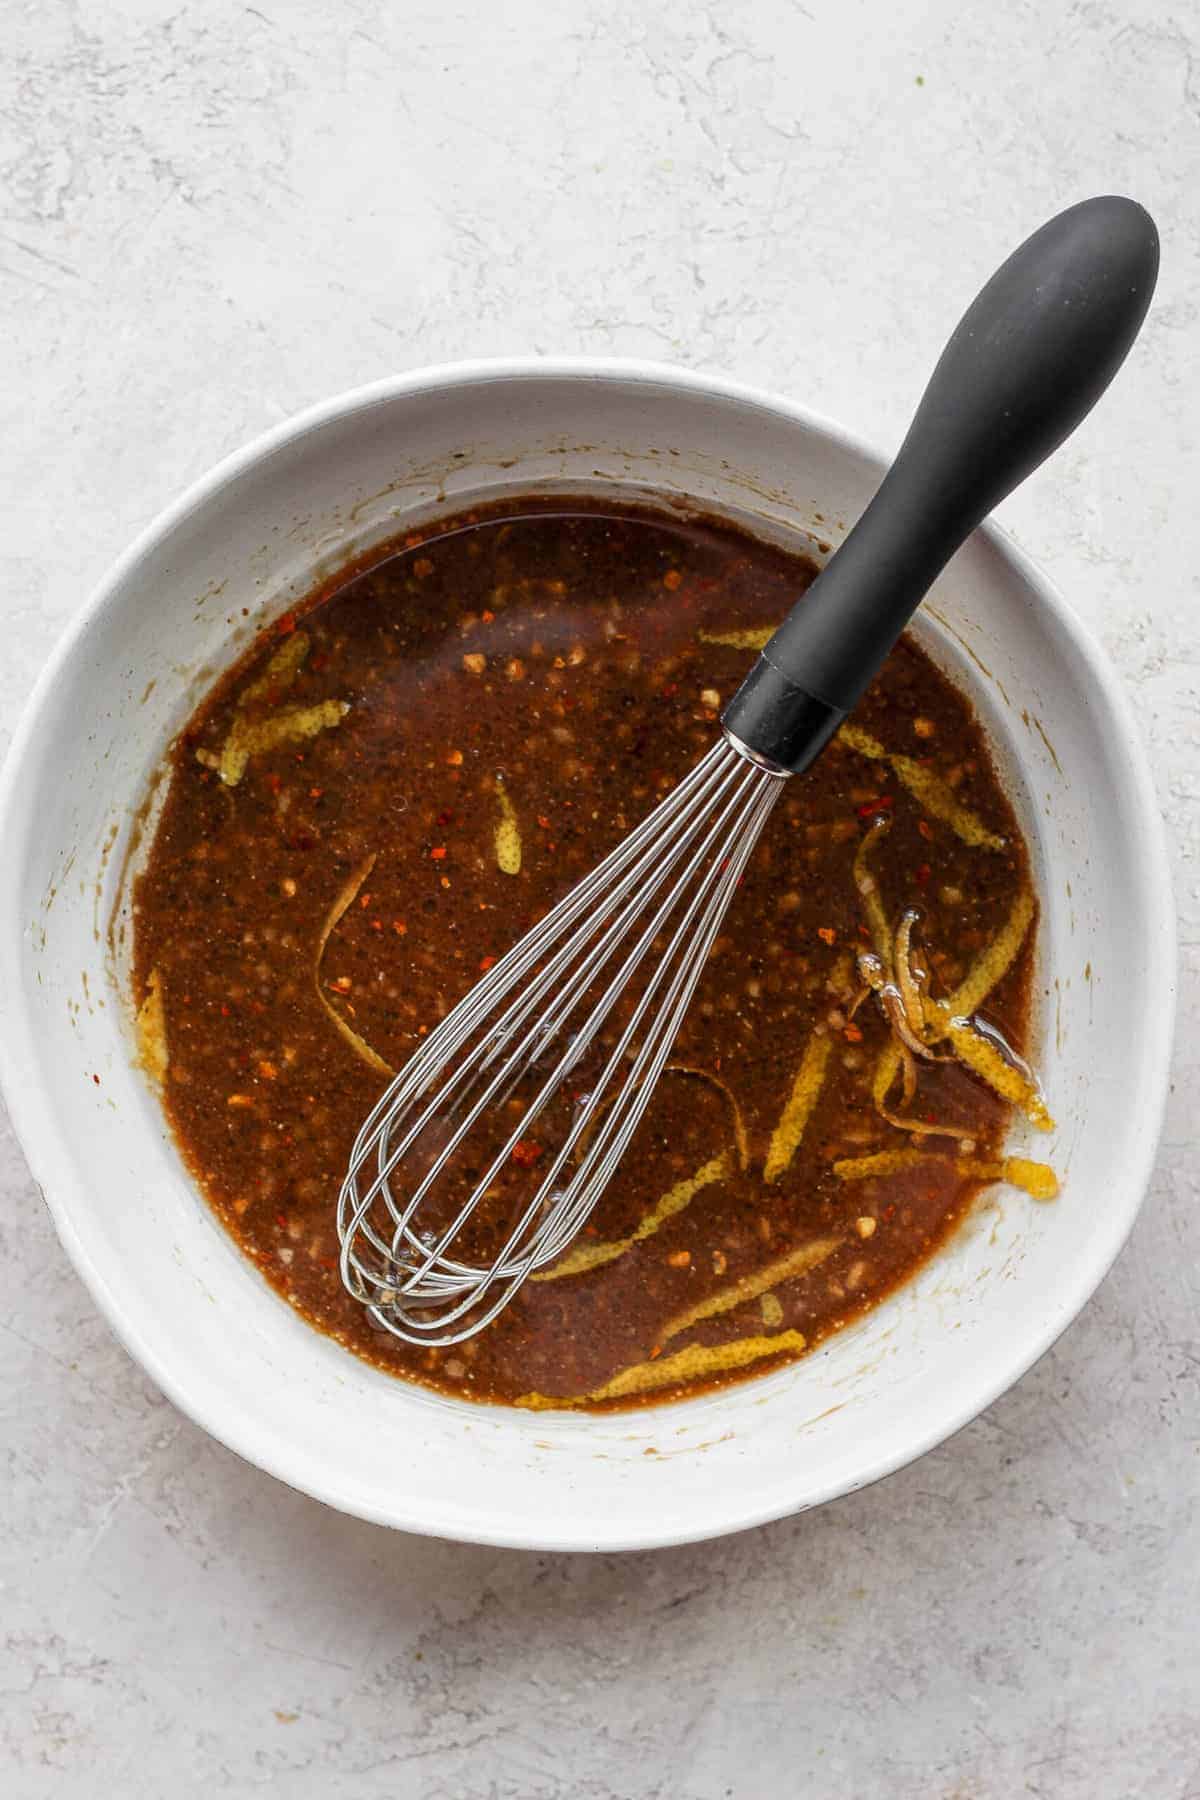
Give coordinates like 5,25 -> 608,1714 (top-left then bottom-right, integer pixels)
0,356 -> 1177,1552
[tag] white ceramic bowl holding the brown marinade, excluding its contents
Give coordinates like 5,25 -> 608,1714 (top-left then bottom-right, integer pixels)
0,360 -> 1173,1550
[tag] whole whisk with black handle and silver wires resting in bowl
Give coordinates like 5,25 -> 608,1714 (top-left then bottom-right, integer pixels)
338,196 -> 1159,1345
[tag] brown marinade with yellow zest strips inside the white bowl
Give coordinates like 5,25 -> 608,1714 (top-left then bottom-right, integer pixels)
135,500 -> 1040,1408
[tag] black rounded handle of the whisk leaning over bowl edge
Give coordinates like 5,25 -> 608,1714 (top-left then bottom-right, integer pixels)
721,196 -> 1159,770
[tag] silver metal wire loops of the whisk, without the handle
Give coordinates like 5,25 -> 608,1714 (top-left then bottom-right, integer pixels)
338,738 -> 783,1345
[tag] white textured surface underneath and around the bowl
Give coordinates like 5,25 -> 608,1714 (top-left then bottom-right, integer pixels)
0,0 -> 1200,1800
